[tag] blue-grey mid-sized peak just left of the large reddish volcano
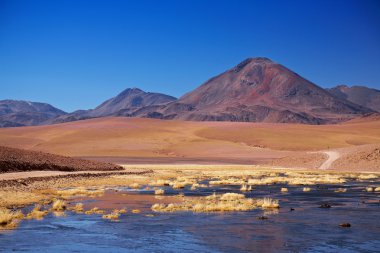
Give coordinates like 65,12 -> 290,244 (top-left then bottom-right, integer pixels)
51,88 -> 177,123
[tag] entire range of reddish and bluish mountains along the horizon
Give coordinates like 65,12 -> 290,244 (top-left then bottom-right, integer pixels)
0,57 -> 380,127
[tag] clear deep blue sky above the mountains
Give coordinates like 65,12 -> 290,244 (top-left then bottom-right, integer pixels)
0,0 -> 380,111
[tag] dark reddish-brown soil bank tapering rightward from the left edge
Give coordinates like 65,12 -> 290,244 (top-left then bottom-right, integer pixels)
0,146 -> 123,173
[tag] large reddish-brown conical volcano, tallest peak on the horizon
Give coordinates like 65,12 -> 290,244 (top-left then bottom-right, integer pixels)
130,57 -> 372,124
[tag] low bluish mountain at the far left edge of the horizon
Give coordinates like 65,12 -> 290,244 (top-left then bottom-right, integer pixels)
0,100 -> 66,127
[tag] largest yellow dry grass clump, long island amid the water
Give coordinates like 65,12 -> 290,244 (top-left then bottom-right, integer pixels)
152,193 -> 279,212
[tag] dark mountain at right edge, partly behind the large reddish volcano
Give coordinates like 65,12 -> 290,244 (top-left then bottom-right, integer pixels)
327,85 -> 380,112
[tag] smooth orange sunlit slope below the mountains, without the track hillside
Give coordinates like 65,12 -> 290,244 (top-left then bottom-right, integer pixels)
0,117 -> 380,158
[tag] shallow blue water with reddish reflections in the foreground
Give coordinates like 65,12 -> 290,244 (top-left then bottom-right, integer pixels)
0,179 -> 380,252
